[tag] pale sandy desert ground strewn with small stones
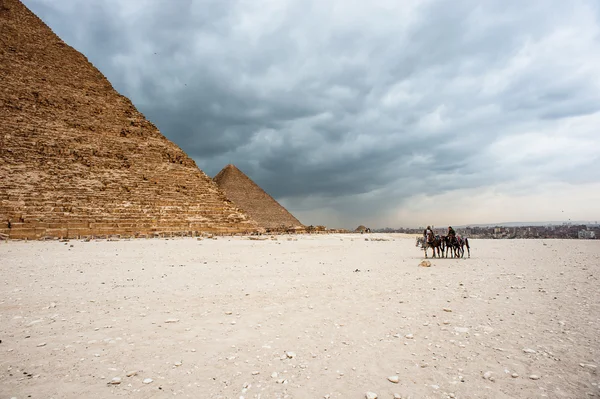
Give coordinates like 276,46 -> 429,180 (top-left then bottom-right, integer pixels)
0,234 -> 600,399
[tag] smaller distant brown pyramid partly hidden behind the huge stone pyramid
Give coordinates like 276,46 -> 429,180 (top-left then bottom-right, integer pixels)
214,164 -> 304,230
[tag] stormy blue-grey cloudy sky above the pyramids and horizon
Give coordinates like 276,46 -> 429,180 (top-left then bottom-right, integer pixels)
23,0 -> 600,228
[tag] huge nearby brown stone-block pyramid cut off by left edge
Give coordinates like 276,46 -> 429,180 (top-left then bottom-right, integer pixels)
0,0 -> 258,239
